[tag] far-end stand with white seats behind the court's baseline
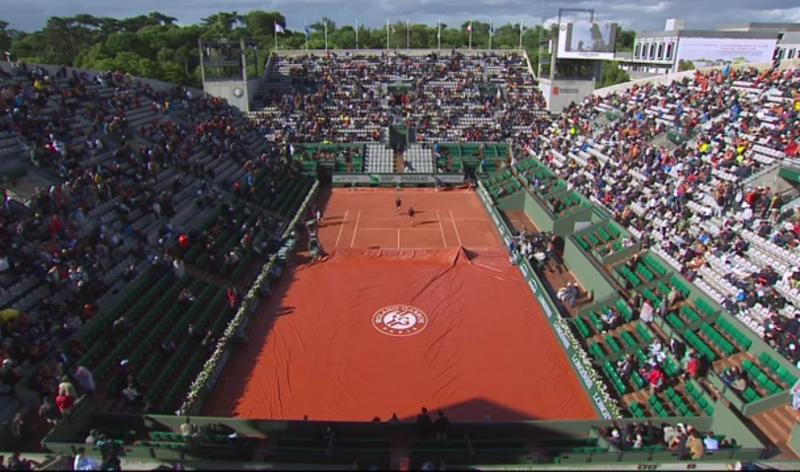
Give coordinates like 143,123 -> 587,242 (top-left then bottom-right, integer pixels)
251,52 -> 545,173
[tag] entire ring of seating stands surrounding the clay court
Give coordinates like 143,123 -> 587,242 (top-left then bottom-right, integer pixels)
0,52 -> 800,467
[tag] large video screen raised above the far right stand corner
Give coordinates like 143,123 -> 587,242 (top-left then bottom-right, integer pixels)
556,22 -> 617,60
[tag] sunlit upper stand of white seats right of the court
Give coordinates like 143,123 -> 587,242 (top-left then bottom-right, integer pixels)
527,65 -> 800,363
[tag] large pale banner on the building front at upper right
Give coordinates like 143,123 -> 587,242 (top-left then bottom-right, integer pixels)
675,38 -> 778,72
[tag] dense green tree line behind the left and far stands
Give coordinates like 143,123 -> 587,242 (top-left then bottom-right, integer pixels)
0,10 -> 576,86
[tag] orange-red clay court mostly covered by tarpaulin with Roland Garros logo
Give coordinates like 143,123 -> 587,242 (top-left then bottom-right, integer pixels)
203,190 -> 596,421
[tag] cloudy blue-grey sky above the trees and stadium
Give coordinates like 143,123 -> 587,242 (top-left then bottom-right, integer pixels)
0,0 -> 800,31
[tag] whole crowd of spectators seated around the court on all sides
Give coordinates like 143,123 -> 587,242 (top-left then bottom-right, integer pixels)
0,52 -> 800,466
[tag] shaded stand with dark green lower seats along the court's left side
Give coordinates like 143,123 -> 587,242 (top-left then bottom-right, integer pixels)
0,61 -> 312,424
